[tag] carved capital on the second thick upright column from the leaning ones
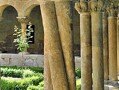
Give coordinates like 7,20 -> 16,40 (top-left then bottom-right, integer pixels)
90,0 -> 104,12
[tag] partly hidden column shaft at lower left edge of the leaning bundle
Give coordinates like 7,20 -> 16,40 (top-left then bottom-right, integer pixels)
44,38 -> 53,90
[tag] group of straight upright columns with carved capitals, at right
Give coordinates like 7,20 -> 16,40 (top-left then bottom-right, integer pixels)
75,0 -> 119,90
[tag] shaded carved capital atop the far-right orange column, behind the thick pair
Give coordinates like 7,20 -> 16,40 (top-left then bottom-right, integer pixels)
107,3 -> 117,17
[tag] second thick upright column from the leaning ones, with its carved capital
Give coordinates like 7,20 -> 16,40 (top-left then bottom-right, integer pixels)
91,0 -> 104,90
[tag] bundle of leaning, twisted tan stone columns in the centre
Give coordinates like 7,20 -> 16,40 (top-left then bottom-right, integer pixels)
40,0 -> 76,90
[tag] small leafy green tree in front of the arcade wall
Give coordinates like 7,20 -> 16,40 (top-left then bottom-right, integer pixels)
13,22 -> 33,52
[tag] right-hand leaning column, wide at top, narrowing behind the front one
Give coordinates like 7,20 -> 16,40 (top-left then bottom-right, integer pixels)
55,0 -> 76,90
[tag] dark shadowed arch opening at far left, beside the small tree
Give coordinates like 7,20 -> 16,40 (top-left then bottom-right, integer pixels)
0,5 -> 19,53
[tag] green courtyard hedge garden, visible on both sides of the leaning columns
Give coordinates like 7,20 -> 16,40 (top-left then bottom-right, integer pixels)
1,66 -> 81,90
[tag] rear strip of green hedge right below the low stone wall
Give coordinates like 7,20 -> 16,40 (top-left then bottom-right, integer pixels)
1,67 -> 43,78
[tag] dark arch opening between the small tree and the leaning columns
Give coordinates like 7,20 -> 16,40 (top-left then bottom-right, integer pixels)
28,5 -> 44,54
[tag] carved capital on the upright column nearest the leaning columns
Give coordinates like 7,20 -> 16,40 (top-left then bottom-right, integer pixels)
75,1 -> 89,14
